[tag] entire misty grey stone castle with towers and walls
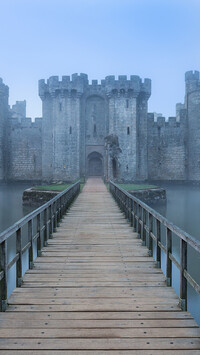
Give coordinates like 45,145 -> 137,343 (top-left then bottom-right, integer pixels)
0,71 -> 200,181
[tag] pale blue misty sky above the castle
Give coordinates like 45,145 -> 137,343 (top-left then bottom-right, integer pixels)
0,0 -> 200,118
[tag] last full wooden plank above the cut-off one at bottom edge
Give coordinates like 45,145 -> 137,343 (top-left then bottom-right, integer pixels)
0,338 -> 199,350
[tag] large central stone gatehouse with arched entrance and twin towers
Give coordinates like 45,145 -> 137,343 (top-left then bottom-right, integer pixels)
39,74 -> 151,181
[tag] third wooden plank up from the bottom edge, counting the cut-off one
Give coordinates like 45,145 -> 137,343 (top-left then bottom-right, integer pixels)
0,328 -> 200,339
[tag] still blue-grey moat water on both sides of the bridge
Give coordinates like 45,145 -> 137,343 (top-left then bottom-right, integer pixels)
0,182 -> 200,325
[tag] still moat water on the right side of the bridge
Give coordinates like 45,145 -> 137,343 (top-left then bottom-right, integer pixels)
148,181 -> 200,324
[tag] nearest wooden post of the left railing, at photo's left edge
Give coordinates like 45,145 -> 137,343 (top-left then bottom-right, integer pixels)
0,240 -> 8,312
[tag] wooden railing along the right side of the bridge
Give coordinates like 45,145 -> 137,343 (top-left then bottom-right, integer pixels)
109,181 -> 200,310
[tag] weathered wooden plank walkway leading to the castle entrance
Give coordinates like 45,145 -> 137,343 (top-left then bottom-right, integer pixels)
0,178 -> 200,355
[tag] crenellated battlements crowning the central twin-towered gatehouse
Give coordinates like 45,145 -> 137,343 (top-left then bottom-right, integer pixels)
39,73 -> 151,99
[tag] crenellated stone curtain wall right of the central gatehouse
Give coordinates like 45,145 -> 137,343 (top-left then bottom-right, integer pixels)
148,111 -> 187,180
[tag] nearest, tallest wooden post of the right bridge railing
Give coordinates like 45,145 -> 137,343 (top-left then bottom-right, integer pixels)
180,239 -> 187,311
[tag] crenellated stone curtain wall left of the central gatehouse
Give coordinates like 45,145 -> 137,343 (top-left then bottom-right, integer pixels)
7,118 -> 42,180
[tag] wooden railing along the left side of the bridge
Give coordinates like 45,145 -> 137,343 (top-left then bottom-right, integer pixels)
0,181 -> 80,311
